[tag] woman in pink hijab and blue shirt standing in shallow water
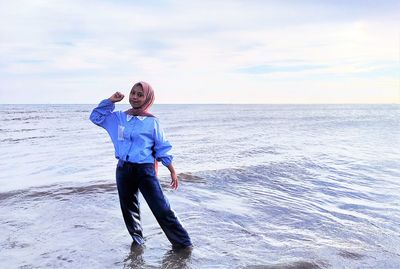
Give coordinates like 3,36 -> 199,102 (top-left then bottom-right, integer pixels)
90,81 -> 192,249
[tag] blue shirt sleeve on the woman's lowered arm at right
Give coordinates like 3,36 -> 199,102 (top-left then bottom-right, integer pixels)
154,120 -> 173,166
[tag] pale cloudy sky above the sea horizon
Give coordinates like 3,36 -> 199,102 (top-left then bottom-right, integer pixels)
0,0 -> 400,104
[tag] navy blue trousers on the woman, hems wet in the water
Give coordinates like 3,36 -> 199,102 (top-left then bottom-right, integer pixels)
116,162 -> 192,248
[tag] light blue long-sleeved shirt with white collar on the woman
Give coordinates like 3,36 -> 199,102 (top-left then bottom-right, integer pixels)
90,99 -> 172,166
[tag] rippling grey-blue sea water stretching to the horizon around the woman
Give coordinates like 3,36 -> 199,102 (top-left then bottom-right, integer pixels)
0,105 -> 400,269
